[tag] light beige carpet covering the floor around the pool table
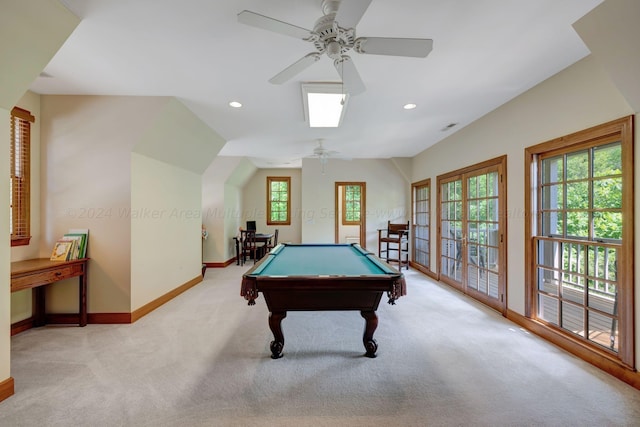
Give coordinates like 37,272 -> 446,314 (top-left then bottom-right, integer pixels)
0,265 -> 640,427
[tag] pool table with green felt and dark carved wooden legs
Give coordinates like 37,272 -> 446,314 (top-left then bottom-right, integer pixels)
240,243 -> 406,359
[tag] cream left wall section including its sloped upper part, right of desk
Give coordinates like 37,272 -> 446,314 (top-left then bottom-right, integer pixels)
130,98 -> 224,304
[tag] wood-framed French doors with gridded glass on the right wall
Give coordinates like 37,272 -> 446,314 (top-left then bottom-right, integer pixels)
438,157 -> 507,314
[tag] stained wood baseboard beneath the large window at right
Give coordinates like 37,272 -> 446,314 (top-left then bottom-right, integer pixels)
507,310 -> 640,390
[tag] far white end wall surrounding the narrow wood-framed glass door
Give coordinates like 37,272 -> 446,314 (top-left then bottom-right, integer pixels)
301,159 -> 411,252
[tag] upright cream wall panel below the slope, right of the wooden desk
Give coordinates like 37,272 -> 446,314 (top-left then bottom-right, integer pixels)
130,153 -> 202,311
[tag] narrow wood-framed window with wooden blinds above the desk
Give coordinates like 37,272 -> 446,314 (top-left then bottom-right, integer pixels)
9,107 -> 35,246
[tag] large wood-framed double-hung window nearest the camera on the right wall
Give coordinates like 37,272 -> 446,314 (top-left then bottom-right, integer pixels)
527,118 -> 634,366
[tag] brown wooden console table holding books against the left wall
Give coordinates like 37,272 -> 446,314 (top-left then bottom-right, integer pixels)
11,258 -> 89,326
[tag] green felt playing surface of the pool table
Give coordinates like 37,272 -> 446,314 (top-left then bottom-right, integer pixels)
251,244 -> 398,276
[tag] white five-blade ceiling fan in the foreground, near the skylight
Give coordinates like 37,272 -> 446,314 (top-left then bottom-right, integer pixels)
238,0 -> 433,95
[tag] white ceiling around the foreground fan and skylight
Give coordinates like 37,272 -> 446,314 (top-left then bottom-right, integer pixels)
31,0 -> 602,167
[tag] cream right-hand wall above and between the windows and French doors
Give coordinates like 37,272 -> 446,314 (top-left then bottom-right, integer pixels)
413,57 -> 633,314
